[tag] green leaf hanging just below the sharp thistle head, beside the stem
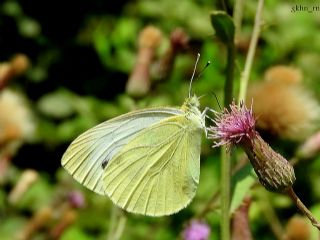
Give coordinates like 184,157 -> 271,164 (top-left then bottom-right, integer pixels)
230,164 -> 257,213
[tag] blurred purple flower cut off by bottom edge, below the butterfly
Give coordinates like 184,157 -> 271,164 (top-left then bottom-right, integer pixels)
182,220 -> 210,240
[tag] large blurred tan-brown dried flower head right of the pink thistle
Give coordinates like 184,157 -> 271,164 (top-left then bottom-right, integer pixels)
247,66 -> 320,140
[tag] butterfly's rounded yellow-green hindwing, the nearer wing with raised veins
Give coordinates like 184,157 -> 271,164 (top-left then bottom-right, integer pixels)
104,116 -> 202,216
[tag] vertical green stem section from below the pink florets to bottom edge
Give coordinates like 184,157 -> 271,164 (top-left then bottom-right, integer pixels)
221,147 -> 231,240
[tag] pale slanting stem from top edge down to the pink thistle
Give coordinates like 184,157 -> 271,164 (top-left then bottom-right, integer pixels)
239,0 -> 264,102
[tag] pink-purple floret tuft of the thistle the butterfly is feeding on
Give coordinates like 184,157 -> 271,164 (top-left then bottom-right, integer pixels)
208,102 -> 256,147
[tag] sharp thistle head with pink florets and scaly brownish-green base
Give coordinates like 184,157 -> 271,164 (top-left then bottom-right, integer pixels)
208,103 -> 295,192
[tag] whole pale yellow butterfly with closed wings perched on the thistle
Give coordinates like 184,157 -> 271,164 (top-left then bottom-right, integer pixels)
61,53 -> 206,216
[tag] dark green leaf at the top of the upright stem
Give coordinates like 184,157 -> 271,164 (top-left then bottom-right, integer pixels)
210,11 -> 235,44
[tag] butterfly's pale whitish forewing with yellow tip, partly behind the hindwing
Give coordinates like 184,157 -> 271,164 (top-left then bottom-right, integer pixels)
61,108 -> 182,195
